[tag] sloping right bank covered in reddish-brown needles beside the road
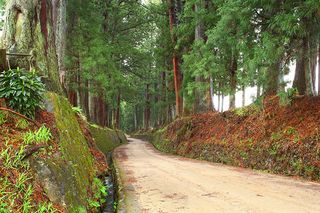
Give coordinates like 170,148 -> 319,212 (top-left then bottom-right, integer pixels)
148,96 -> 320,181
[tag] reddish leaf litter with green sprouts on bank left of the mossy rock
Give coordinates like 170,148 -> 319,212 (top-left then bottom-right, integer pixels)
0,111 -> 64,212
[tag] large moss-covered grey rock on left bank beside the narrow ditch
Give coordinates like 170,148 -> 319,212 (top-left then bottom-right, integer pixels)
33,93 -> 96,212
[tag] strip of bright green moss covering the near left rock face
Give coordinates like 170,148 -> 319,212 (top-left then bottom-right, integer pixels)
48,93 -> 95,212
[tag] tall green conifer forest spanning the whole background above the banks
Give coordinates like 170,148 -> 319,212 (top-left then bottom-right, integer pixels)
5,0 -> 320,130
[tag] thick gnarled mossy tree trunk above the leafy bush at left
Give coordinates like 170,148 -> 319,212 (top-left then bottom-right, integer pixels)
3,0 -> 63,93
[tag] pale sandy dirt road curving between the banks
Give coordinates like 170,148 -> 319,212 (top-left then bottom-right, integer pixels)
114,139 -> 320,213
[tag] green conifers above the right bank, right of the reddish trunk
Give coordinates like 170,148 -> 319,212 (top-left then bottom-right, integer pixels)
168,0 -> 320,113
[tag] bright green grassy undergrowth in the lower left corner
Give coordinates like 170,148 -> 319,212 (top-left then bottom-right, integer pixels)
0,113 -> 59,213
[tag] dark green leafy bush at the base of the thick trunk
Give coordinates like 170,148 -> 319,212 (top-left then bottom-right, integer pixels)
0,68 -> 45,118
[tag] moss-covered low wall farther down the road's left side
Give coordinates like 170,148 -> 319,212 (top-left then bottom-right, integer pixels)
90,125 -> 126,153
